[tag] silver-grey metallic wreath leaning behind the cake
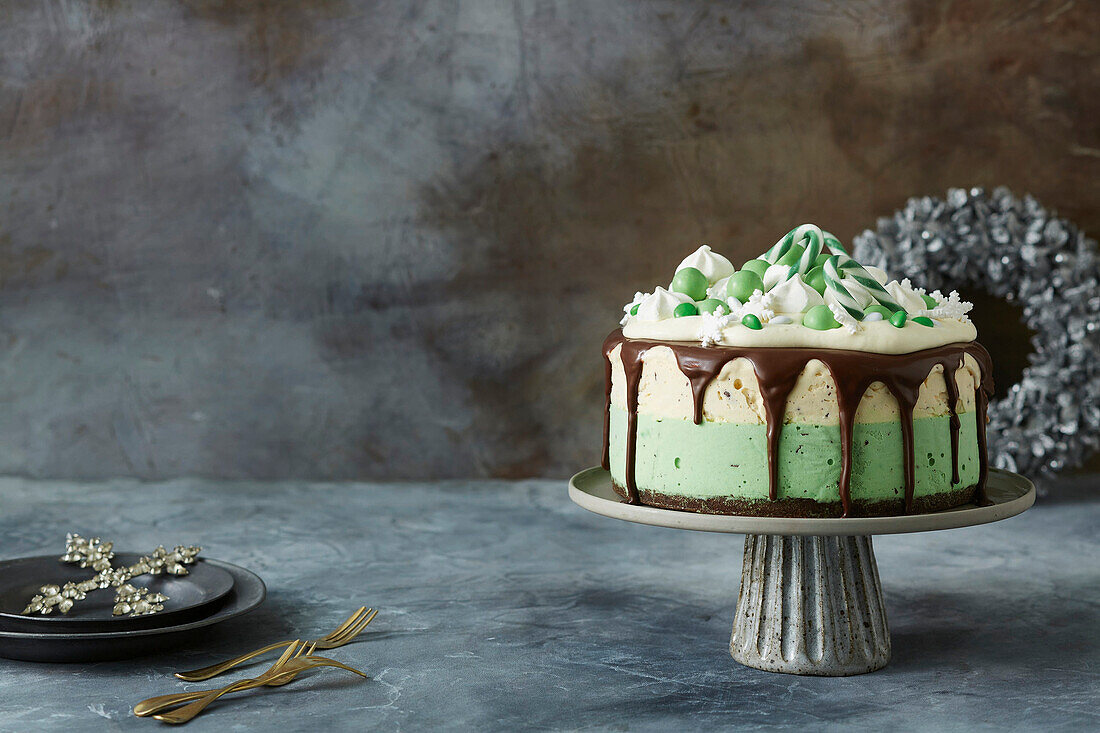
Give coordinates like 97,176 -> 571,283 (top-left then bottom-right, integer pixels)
853,188 -> 1100,477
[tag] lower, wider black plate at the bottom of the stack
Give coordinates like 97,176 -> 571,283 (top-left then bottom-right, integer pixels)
0,559 -> 267,661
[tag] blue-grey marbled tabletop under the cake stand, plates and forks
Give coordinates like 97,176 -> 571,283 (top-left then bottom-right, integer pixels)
0,478 -> 1100,731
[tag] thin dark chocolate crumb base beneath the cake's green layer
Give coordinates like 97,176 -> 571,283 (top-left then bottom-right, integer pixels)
612,480 -> 977,518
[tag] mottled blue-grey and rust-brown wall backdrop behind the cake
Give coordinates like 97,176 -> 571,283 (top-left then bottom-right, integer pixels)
0,0 -> 1100,478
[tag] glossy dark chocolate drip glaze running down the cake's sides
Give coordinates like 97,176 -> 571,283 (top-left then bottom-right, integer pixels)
603,330 -> 993,516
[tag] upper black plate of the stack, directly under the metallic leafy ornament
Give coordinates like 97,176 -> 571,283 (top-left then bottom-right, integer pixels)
0,553 -> 233,633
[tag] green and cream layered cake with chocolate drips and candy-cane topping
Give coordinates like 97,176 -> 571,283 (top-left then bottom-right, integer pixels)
603,225 -> 993,516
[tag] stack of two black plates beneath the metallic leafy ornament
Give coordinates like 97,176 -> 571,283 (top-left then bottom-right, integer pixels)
0,553 -> 267,661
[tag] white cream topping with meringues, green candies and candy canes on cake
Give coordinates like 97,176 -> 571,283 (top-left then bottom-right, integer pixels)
622,230 -> 977,353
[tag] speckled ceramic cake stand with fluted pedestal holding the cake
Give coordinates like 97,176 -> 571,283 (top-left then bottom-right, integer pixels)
569,468 -> 1035,677
